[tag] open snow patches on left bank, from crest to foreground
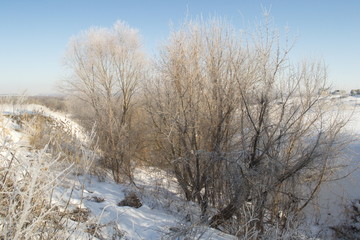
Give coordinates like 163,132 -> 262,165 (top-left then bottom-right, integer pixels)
0,105 -> 235,240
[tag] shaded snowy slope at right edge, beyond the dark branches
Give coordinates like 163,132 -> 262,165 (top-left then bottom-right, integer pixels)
305,96 -> 360,237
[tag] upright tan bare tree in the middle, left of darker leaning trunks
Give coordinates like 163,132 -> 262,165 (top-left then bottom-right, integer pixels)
148,19 -> 241,215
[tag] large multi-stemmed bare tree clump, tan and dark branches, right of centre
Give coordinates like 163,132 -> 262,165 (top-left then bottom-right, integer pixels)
147,16 -> 344,233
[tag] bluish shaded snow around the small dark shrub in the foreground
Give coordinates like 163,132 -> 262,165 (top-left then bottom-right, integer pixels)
51,170 -> 235,240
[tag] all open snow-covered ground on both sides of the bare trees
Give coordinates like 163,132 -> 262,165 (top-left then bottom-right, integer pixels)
0,97 -> 360,239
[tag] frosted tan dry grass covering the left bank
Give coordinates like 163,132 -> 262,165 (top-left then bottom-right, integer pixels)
0,110 -> 102,240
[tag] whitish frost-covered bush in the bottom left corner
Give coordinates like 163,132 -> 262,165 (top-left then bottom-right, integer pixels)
0,145 -> 71,240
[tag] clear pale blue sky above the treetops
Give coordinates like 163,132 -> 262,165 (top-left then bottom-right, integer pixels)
0,0 -> 360,94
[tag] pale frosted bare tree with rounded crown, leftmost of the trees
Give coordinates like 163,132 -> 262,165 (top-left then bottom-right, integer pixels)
65,22 -> 146,182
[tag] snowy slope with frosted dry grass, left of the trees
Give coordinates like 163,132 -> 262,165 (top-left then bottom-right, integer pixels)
0,105 -> 233,239
